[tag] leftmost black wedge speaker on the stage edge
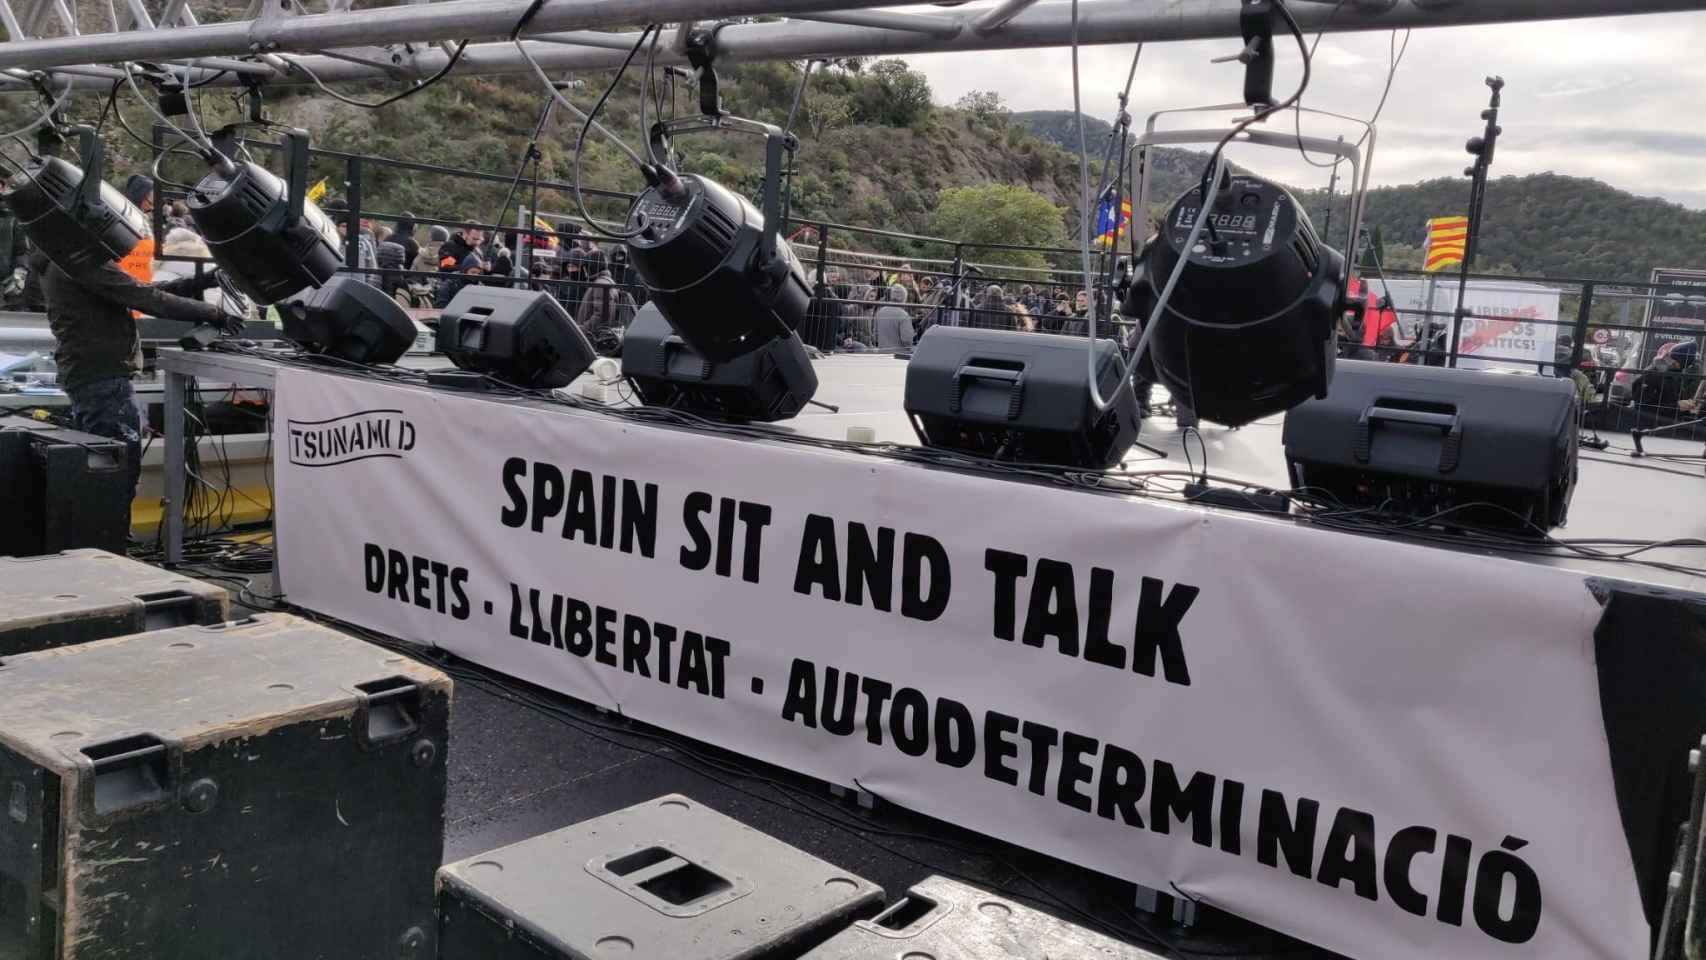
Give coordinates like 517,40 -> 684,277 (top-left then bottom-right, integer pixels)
278,275 -> 415,371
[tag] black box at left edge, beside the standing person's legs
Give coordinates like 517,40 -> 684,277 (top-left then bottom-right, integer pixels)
0,416 -> 131,556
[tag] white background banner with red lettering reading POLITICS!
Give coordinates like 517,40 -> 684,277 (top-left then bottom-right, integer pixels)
1368,275 -> 1559,373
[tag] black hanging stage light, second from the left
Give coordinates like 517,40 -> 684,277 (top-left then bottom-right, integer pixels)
186,130 -> 343,304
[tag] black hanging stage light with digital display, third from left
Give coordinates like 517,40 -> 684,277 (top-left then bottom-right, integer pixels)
628,116 -> 812,363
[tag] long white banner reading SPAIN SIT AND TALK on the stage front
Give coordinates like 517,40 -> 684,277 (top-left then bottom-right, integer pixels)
275,370 -> 1648,960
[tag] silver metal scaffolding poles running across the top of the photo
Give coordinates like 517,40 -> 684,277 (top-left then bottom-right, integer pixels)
0,0 -> 1701,85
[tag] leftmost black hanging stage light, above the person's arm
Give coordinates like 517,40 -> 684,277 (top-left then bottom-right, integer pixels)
5,126 -> 148,273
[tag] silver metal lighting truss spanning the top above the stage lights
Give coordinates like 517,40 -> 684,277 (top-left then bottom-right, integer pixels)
0,0 -> 1706,90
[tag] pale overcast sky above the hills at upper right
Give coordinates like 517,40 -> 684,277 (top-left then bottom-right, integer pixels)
908,12 -> 1706,210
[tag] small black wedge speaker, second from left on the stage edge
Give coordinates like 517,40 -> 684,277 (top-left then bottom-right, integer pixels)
438,285 -> 597,389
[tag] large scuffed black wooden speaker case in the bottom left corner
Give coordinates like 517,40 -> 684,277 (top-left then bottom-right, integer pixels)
0,617 -> 450,960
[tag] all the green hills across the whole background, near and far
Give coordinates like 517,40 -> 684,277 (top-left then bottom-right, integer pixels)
0,60 -> 1706,280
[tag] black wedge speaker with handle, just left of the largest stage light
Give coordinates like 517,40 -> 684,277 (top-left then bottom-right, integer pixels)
906,326 -> 1140,469
